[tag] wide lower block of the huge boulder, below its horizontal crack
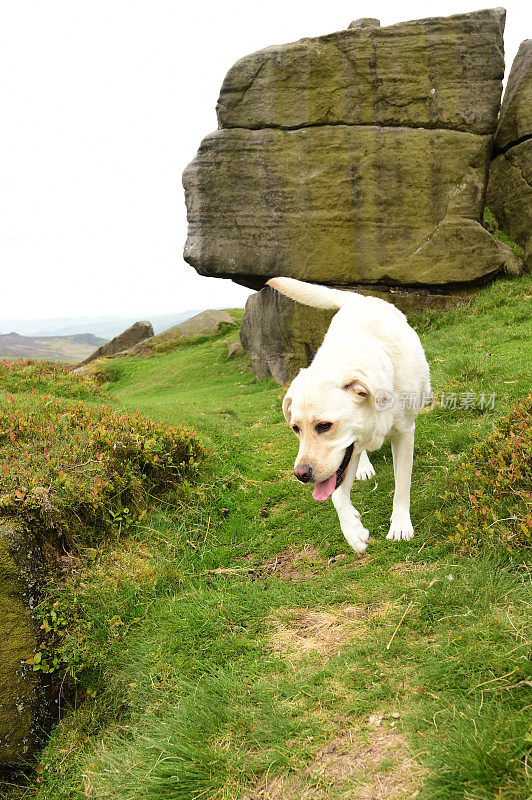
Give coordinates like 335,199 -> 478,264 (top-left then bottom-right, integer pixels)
184,125 -> 502,288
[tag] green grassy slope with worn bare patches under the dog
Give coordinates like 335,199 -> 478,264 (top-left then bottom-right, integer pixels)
5,278 -> 532,800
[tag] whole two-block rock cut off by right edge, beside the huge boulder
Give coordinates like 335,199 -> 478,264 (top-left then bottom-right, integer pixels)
486,39 -> 532,271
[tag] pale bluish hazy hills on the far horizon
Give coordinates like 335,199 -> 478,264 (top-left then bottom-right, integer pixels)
0,309 -> 203,340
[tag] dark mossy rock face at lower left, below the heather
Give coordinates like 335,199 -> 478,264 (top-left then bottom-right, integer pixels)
0,521 -> 46,769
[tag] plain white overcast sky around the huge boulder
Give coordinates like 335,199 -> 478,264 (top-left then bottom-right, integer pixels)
0,0 -> 532,319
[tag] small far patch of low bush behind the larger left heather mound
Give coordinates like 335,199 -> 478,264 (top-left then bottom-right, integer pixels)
0,358 -> 101,399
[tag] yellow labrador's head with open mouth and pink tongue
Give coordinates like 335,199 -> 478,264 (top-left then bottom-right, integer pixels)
283,370 -> 380,500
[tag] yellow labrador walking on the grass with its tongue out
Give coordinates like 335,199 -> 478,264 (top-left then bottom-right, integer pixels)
268,278 -> 430,553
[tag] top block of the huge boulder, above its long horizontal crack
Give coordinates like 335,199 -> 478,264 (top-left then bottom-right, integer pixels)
218,8 -> 505,134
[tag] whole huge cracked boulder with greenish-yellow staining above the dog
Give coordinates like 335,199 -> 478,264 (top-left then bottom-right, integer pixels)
184,9 -> 504,288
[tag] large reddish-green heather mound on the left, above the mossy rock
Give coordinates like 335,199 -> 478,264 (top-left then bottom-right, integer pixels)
0,390 -> 204,545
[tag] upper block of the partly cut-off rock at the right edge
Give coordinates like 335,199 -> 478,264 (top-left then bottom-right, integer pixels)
495,39 -> 532,150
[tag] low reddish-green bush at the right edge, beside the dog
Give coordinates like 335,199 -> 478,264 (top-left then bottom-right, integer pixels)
442,396 -> 532,550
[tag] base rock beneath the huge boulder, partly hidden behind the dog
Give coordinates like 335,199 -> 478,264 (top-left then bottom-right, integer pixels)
240,286 -> 471,385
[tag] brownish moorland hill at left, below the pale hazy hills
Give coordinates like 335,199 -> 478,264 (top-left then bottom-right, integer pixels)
0,332 -> 107,364
